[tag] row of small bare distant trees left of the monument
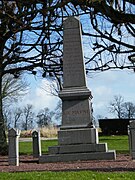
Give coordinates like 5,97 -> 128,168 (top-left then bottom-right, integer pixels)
4,104 -> 57,131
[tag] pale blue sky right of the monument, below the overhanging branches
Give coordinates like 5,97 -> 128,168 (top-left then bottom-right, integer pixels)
88,70 -> 135,118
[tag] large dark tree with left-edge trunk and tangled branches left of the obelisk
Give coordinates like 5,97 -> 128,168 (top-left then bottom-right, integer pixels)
0,0 -> 62,154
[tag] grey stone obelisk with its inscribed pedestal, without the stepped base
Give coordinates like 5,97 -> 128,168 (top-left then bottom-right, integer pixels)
59,17 -> 92,129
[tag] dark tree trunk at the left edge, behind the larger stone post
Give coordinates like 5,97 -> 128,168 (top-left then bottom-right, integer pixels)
0,72 -> 8,155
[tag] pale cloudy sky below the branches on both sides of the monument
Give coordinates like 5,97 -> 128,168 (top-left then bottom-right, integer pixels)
20,70 -> 135,121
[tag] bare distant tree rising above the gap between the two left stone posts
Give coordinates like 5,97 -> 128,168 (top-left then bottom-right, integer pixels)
22,104 -> 35,131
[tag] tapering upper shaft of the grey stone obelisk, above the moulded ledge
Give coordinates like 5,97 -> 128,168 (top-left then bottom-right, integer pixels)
63,17 -> 86,87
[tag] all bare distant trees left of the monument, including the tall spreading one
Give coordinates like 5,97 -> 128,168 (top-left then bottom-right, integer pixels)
2,75 -> 60,130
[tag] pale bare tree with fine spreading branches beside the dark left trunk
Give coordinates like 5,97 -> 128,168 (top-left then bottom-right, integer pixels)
2,74 -> 29,131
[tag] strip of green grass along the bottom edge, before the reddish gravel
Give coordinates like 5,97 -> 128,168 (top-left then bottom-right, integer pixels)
0,171 -> 135,180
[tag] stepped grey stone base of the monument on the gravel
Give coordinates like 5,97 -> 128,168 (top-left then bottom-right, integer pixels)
39,128 -> 116,163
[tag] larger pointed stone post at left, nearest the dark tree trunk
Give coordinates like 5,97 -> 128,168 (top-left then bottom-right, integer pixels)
8,128 -> 20,166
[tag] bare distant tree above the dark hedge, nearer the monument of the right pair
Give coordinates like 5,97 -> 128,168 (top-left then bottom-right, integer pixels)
109,95 -> 124,119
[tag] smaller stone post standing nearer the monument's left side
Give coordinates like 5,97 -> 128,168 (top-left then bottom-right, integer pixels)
32,130 -> 41,158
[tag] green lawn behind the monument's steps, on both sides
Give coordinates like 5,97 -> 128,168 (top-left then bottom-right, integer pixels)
19,136 -> 129,154
